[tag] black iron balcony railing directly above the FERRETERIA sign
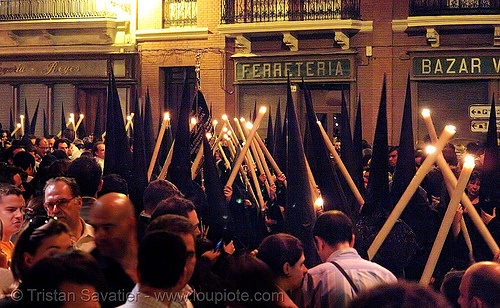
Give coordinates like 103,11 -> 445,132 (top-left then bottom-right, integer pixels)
222,0 -> 361,24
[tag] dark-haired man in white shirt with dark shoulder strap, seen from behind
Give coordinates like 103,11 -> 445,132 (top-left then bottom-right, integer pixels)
294,211 -> 397,308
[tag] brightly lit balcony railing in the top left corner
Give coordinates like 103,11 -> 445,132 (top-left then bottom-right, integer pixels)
0,0 -> 116,21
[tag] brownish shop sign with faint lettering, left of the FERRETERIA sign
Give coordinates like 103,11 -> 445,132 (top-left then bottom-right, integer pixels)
0,60 -> 106,78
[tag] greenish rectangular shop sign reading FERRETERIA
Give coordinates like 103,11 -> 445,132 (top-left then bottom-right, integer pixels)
236,59 -> 353,81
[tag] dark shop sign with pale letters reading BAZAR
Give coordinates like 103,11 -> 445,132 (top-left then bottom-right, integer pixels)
413,55 -> 500,78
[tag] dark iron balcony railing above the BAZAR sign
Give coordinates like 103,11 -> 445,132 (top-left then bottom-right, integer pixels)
409,0 -> 500,16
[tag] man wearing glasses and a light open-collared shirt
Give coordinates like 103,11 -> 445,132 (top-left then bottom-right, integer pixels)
43,177 -> 95,252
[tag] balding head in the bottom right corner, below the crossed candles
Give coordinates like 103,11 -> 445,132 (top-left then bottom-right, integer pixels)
458,261 -> 500,308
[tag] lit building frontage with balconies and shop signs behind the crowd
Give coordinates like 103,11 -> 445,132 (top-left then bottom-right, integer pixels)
0,0 -> 500,148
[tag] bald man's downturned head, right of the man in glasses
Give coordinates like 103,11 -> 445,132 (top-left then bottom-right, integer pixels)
90,193 -> 136,260
